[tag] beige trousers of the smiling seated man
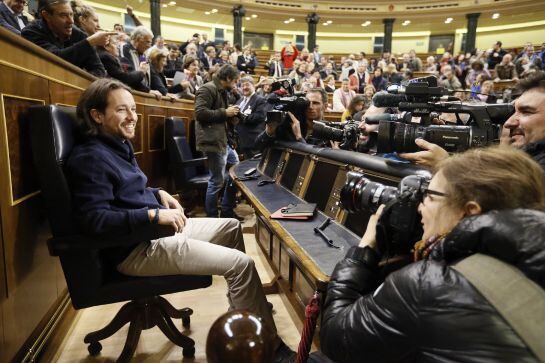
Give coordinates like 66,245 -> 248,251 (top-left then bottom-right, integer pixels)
117,218 -> 276,332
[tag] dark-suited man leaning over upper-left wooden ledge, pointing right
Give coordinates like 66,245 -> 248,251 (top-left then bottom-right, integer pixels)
21,0 -> 107,77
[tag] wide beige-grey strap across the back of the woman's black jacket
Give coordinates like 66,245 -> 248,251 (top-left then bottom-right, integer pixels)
452,253 -> 545,362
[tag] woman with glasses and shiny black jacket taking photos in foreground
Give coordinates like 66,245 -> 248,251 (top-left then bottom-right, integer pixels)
320,147 -> 545,362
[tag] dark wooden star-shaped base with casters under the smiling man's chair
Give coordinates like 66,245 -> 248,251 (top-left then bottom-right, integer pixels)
83,296 -> 195,362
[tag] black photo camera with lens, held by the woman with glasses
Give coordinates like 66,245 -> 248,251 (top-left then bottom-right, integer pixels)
341,171 -> 431,256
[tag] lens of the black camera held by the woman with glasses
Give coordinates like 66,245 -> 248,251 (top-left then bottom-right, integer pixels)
341,171 -> 399,213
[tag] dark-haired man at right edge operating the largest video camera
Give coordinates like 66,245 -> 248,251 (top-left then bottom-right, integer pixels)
400,72 -> 545,169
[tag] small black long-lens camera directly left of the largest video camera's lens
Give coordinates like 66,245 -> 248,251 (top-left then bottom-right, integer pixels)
312,119 -> 360,150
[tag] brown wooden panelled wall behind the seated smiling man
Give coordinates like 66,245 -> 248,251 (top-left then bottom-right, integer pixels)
0,28 -> 193,362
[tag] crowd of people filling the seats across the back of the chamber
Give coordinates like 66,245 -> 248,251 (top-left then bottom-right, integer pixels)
0,0 -> 545,112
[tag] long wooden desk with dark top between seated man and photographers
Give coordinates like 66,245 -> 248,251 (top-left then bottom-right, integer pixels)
231,143 -> 422,319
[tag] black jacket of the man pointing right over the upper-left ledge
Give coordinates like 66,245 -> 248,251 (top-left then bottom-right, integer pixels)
21,19 -> 106,77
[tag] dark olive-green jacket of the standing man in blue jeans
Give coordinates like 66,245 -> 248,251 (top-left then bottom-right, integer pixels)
195,77 -> 229,152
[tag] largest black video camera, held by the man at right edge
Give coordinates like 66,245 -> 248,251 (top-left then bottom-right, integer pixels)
366,76 -> 514,153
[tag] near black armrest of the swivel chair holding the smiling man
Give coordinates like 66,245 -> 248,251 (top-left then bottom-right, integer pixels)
47,224 -> 176,256
